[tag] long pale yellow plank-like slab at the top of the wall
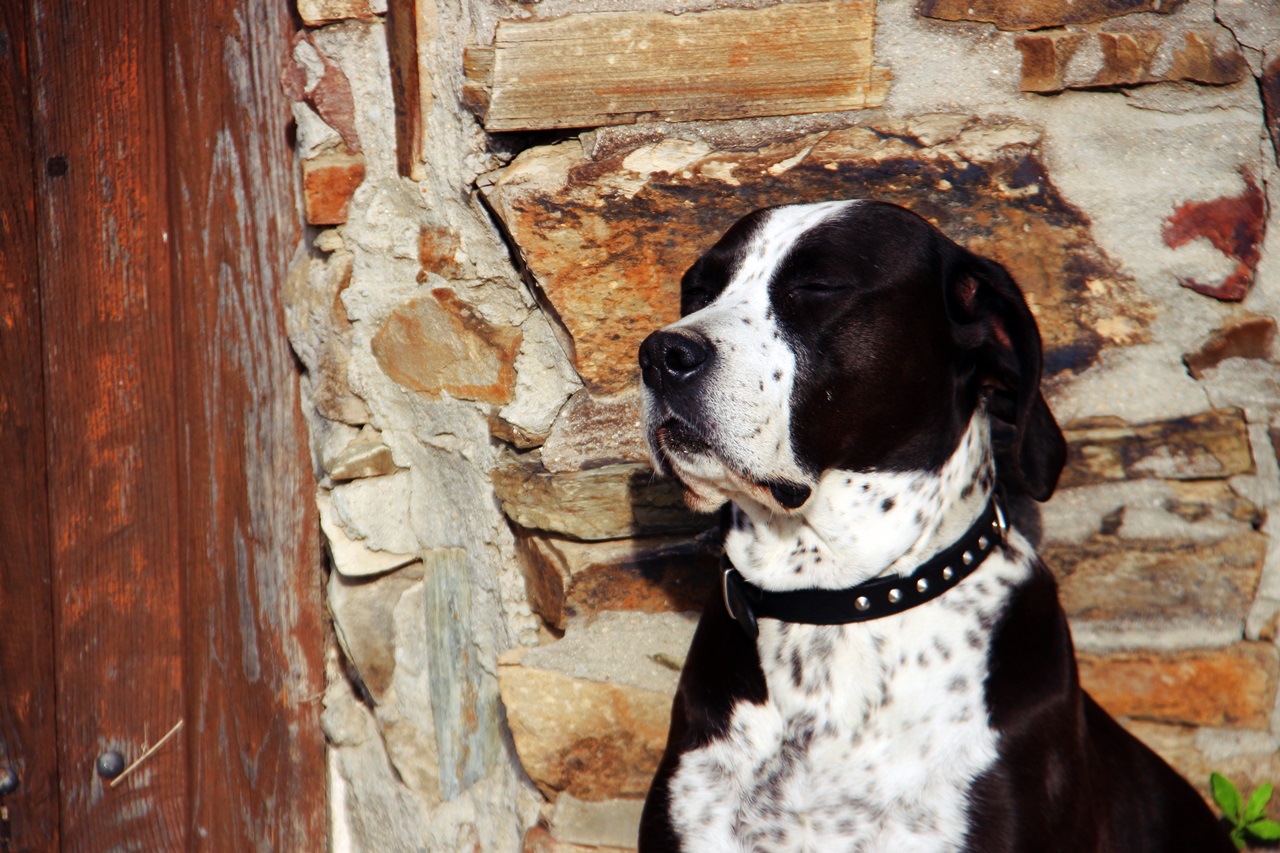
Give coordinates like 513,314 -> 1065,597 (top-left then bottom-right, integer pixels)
466,0 -> 888,131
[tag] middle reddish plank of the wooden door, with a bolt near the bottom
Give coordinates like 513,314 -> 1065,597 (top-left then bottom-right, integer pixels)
32,0 -> 187,850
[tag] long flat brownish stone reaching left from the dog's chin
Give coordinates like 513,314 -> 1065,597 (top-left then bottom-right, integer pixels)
493,453 -> 714,540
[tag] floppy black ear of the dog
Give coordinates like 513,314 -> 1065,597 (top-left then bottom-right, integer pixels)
946,247 -> 1066,501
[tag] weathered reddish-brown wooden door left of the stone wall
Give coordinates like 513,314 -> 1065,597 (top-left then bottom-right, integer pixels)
0,0 -> 325,850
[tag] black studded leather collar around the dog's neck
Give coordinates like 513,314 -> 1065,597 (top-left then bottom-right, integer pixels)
721,493 -> 1007,639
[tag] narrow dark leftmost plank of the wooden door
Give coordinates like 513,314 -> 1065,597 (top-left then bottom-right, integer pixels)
0,0 -> 58,850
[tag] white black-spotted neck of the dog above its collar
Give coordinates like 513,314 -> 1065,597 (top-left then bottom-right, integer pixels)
724,411 -> 995,590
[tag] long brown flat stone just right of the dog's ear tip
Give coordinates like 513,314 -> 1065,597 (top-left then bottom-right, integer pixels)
1059,409 -> 1253,488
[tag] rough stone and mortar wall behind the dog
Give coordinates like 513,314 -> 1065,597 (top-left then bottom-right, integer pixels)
282,0 -> 1280,853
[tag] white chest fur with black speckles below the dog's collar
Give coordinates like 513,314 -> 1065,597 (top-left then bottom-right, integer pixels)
671,534 -> 1030,853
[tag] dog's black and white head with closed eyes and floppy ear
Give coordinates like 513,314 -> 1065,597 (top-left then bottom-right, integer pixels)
640,201 -> 1066,511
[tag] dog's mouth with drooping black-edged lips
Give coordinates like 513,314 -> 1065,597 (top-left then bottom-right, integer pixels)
650,418 -> 812,512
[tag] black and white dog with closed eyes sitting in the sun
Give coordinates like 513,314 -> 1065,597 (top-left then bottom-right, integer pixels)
640,201 -> 1233,853
